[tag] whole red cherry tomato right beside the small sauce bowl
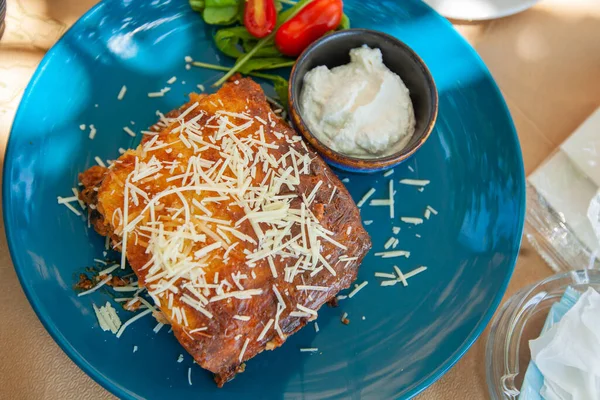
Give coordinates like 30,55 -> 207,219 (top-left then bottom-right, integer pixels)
275,0 -> 344,57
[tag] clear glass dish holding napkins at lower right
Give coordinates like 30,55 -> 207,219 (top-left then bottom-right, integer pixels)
485,269 -> 600,400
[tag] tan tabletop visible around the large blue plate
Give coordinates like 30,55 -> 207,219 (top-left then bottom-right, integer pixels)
0,0 -> 600,400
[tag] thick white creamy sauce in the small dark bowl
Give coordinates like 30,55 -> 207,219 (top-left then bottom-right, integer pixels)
300,45 -> 415,158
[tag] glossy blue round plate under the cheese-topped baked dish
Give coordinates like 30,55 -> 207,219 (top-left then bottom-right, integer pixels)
3,0 -> 524,399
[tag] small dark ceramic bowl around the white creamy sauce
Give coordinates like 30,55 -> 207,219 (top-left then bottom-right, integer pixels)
289,29 -> 438,172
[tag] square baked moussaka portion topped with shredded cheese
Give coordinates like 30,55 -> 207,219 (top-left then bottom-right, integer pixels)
80,78 -> 371,386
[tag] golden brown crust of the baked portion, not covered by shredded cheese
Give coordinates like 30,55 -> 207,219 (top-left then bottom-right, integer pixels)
80,78 -> 371,386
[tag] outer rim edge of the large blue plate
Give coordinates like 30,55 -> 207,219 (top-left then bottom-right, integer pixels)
2,1 -> 525,399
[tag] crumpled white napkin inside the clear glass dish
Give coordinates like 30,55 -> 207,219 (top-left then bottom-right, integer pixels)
529,288 -> 600,400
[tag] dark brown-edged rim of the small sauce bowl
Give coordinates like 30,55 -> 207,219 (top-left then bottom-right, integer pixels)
288,28 -> 438,168
